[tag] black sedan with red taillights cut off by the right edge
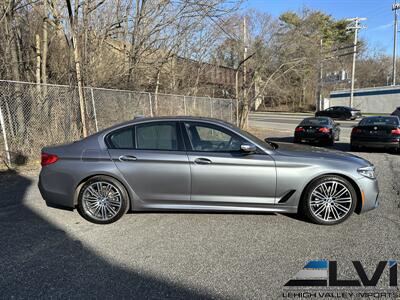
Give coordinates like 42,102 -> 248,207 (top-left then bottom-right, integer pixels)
350,116 -> 400,151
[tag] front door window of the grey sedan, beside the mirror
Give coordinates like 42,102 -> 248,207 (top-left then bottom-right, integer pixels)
185,122 -> 244,152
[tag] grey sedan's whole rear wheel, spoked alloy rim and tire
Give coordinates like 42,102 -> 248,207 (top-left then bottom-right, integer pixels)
78,175 -> 129,224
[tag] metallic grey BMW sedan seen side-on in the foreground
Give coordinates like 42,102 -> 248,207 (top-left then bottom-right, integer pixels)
39,117 -> 378,225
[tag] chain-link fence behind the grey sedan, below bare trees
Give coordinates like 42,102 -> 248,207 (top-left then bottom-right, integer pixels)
0,80 -> 235,166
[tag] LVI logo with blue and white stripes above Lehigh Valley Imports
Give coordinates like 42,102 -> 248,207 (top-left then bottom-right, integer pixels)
285,260 -> 397,287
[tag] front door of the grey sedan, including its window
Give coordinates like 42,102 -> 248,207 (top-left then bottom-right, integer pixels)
182,122 -> 276,206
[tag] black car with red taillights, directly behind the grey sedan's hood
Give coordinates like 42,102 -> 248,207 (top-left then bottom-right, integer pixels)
294,117 -> 340,146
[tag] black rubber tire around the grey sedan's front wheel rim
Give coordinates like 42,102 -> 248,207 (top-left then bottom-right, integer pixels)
301,175 -> 357,225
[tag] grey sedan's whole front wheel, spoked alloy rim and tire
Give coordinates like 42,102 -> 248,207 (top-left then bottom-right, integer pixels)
300,175 -> 357,225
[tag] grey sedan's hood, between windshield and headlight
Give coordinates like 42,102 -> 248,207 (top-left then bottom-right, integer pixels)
275,143 -> 372,167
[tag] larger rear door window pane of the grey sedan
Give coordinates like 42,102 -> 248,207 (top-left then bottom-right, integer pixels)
136,122 -> 179,151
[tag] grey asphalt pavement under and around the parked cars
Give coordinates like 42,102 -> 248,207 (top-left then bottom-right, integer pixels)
0,114 -> 400,299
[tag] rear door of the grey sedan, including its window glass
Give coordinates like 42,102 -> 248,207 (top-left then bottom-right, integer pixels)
106,121 -> 190,202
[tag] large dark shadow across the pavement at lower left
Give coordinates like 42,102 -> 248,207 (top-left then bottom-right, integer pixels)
0,171 -> 216,299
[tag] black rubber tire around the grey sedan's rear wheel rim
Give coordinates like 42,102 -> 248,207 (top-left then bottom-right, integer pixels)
77,175 -> 129,224
